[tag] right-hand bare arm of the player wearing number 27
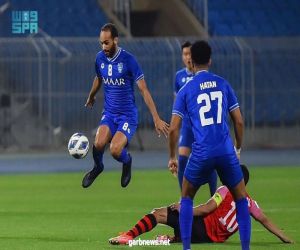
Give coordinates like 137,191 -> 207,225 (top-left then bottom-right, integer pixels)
230,108 -> 244,158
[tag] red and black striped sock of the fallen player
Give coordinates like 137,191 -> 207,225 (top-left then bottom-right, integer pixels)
127,214 -> 157,238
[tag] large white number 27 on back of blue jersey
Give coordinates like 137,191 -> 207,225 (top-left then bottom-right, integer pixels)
197,91 -> 223,127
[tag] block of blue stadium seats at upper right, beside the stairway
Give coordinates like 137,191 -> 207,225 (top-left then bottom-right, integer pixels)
187,0 -> 300,36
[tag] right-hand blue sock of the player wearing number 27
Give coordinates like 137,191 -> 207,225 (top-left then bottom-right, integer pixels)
235,198 -> 251,250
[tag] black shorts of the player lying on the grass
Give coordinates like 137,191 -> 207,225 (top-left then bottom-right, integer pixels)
167,207 -> 212,243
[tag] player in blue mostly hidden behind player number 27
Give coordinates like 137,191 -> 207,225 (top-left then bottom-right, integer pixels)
174,41 -> 217,195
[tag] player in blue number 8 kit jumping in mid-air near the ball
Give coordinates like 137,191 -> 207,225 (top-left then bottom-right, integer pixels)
82,23 -> 169,188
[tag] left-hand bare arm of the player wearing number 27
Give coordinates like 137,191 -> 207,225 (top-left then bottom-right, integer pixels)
168,114 -> 182,175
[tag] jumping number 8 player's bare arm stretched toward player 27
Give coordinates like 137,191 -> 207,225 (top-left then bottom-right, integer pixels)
137,79 -> 169,137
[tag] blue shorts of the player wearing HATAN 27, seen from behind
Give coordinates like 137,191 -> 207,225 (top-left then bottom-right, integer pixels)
184,153 -> 243,188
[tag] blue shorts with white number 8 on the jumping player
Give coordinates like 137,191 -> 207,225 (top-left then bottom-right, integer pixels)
99,113 -> 137,143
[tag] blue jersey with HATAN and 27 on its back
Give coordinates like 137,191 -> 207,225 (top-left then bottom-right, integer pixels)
172,71 -> 239,158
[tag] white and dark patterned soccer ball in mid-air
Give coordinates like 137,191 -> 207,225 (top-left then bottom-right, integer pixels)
68,133 -> 89,159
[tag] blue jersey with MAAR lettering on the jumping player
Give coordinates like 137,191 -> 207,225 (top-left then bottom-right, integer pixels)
95,48 -> 144,120
